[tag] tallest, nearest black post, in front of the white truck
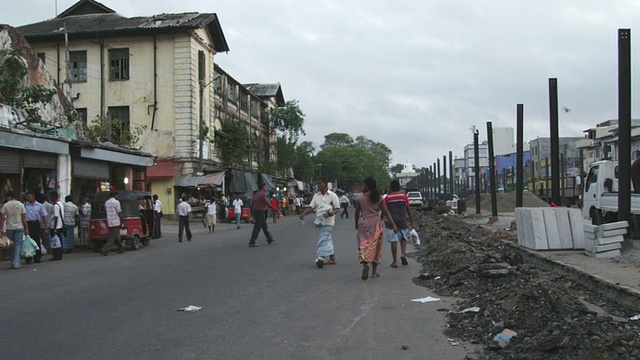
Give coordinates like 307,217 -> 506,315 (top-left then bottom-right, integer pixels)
618,29 -> 631,221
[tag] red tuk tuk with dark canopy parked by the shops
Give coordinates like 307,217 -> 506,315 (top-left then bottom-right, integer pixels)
89,190 -> 154,251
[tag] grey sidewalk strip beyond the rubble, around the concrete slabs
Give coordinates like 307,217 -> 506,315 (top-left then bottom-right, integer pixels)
465,213 -> 640,298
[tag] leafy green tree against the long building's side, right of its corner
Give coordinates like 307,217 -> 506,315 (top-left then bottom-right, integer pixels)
215,117 -> 250,169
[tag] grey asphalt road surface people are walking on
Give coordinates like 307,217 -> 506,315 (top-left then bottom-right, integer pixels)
0,210 -> 468,360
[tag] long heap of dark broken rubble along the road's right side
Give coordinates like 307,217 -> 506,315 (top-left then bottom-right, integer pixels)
415,212 -> 640,359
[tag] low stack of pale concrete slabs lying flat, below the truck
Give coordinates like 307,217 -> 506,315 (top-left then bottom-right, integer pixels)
584,221 -> 629,258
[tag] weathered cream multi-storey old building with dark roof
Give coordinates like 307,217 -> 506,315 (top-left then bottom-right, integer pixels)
18,0 -> 284,213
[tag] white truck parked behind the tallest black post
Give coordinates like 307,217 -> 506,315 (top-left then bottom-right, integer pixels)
582,160 -> 640,227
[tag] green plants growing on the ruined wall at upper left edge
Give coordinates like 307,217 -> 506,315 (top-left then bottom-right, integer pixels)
0,47 -> 56,125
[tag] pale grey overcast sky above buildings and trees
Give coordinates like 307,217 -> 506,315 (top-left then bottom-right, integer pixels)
0,0 -> 640,167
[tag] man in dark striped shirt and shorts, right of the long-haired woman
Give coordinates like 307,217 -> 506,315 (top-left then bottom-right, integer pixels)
384,180 -> 413,268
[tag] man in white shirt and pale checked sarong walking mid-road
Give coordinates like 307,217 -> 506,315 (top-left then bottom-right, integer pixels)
300,178 -> 340,269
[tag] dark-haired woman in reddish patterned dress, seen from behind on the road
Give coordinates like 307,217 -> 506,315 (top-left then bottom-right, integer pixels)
355,177 -> 398,280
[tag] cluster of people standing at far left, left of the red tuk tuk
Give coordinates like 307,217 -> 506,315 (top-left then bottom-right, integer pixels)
0,191 -> 91,269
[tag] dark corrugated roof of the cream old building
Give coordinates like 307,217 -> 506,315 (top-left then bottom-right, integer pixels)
17,12 -> 229,51
